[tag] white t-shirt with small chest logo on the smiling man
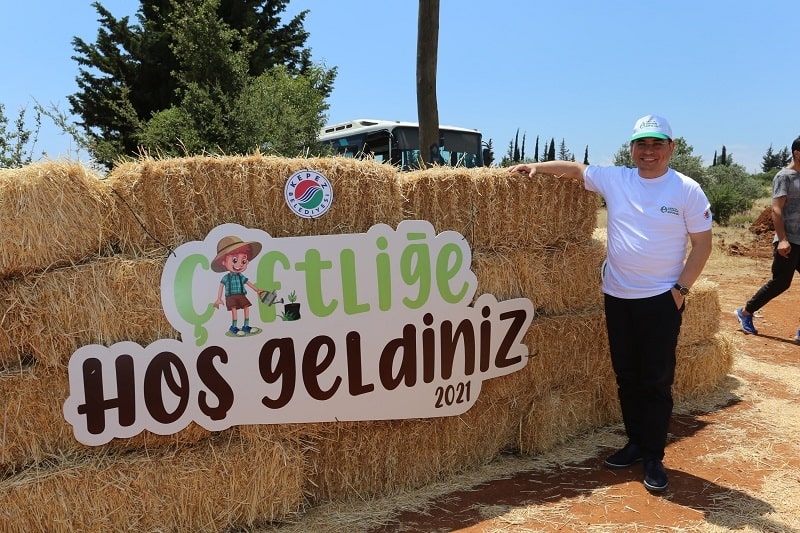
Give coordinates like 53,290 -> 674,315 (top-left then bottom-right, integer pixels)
584,165 -> 711,298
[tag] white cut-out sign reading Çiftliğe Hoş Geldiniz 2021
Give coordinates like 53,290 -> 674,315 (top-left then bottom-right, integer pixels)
63,220 -> 534,445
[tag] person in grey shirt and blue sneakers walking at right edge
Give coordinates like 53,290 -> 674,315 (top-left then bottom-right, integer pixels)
734,137 -> 800,341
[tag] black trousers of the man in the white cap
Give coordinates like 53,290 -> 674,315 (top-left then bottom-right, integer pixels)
605,291 -> 683,460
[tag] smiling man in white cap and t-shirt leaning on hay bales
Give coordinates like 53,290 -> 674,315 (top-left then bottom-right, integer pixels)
508,115 -> 712,492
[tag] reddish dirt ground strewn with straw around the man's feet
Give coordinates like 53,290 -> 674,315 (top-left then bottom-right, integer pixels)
266,214 -> 800,533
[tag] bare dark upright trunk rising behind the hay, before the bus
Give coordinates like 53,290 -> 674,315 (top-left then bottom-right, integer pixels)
417,0 -> 442,166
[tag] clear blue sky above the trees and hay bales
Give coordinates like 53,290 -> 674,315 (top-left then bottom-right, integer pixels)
0,0 -> 800,172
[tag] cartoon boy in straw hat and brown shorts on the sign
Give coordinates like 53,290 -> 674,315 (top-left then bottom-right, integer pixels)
211,237 -> 264,335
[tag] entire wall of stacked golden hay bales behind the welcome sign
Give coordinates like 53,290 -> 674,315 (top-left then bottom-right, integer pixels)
0,156 -> 732,531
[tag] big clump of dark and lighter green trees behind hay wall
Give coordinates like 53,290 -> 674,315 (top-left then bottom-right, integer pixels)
69,0 -> 336,166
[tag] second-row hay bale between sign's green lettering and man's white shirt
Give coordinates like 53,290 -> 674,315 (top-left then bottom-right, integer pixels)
472,241 -> 605,315
